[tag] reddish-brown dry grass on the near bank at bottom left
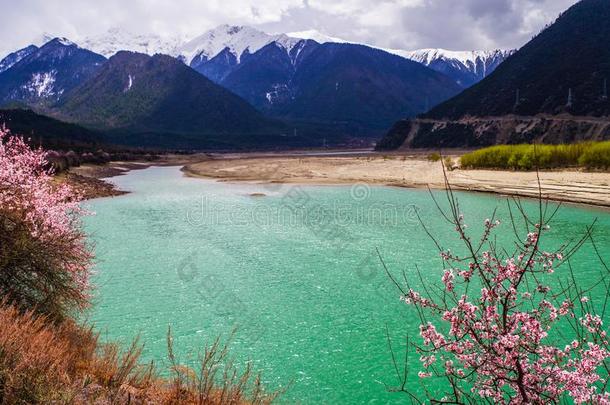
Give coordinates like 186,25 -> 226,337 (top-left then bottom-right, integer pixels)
0,302 -> 278,404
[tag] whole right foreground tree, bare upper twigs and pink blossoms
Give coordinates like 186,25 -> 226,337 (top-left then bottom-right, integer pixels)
382,178 -> 610,404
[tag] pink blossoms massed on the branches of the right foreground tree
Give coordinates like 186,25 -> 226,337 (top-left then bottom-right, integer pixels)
403,216 -> 610,404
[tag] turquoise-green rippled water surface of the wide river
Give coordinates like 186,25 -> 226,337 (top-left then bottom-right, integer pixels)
86,167 -> 610,403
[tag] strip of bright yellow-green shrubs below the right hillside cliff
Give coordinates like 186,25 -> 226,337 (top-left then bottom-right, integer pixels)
460,142 -> 610,170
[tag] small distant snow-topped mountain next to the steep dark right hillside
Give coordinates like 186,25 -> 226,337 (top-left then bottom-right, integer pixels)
401,49 -> 516,87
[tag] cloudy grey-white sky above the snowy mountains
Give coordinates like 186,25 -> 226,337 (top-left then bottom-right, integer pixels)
0,0 -> 576,55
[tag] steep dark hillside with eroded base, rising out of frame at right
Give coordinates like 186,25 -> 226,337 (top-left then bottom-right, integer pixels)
379,0 -> 610,148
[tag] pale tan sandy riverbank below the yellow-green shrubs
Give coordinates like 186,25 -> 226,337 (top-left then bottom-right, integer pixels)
183,154 -> 610,207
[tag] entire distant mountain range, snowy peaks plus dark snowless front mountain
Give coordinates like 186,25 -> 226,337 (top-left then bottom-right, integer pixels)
0,25 -> 510,148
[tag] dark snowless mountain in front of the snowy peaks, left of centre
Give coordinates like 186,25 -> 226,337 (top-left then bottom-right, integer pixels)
57,51 -> 282,148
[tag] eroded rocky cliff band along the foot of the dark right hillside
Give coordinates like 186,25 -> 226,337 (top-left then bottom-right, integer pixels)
377,115 -> 610,150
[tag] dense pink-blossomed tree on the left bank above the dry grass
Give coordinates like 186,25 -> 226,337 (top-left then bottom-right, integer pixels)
0,127 -> 92,320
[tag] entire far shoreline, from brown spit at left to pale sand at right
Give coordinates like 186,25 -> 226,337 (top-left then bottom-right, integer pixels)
63,153 -> 610,210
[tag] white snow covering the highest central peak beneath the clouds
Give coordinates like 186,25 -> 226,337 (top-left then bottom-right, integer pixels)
179,24 -> 301,65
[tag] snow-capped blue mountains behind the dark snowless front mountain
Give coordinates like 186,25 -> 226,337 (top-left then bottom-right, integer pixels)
0,25 -> 510,141
